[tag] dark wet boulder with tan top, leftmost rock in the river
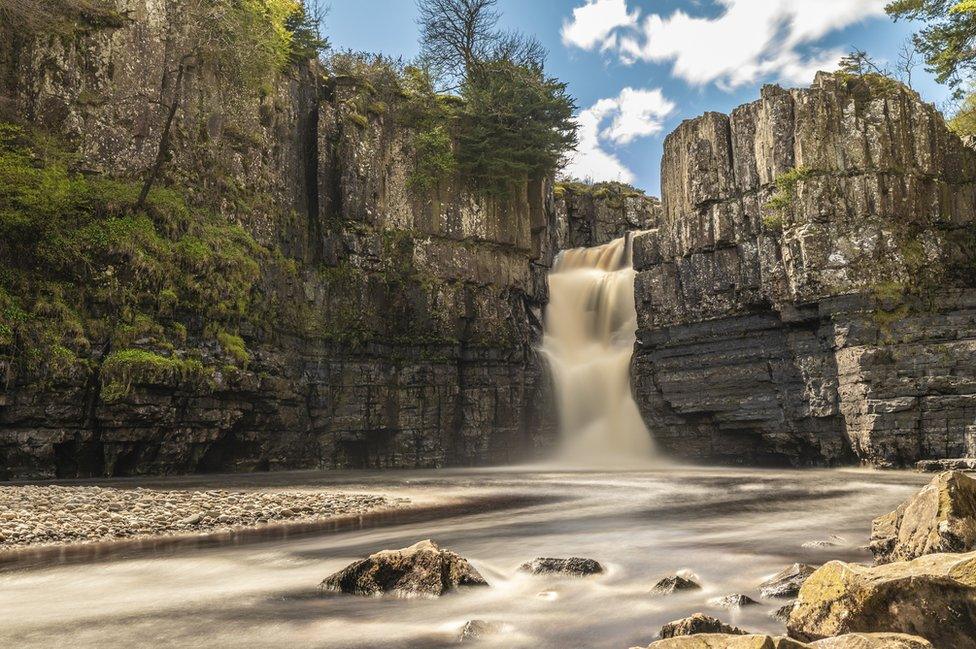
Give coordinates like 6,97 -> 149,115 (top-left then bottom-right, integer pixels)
319,540 -> 488,597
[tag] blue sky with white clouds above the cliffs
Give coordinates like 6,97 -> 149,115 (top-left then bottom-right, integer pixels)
322,0 -> 949,195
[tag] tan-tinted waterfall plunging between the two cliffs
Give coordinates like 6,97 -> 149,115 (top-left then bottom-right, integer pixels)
542,234 -> 653,463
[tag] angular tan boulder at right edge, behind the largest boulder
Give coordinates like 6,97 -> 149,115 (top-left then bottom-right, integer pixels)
871,471 -> 976,563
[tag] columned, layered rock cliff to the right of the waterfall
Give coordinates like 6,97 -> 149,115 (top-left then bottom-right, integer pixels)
633,74 -> 976,465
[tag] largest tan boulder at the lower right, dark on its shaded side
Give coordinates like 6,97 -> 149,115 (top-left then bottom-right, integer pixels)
787,552 -> 976,649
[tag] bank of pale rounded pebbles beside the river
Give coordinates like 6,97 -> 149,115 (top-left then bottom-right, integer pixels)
0,486 -> 406,550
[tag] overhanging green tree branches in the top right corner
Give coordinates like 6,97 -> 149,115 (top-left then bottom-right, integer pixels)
886,0 -> 976,98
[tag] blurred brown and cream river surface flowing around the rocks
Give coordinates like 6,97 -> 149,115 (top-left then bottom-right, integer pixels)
0,467 -> 926,649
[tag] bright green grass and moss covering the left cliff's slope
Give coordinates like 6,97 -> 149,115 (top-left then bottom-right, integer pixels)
0,124 -> 268,375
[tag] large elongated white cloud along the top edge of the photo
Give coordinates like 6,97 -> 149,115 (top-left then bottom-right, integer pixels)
563,0 -> 887,88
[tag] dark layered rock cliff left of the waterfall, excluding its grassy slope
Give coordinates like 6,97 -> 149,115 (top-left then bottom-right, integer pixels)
0,0 -> 555,478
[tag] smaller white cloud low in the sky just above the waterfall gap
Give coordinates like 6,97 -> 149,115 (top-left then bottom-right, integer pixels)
565,88 -> 676,184
